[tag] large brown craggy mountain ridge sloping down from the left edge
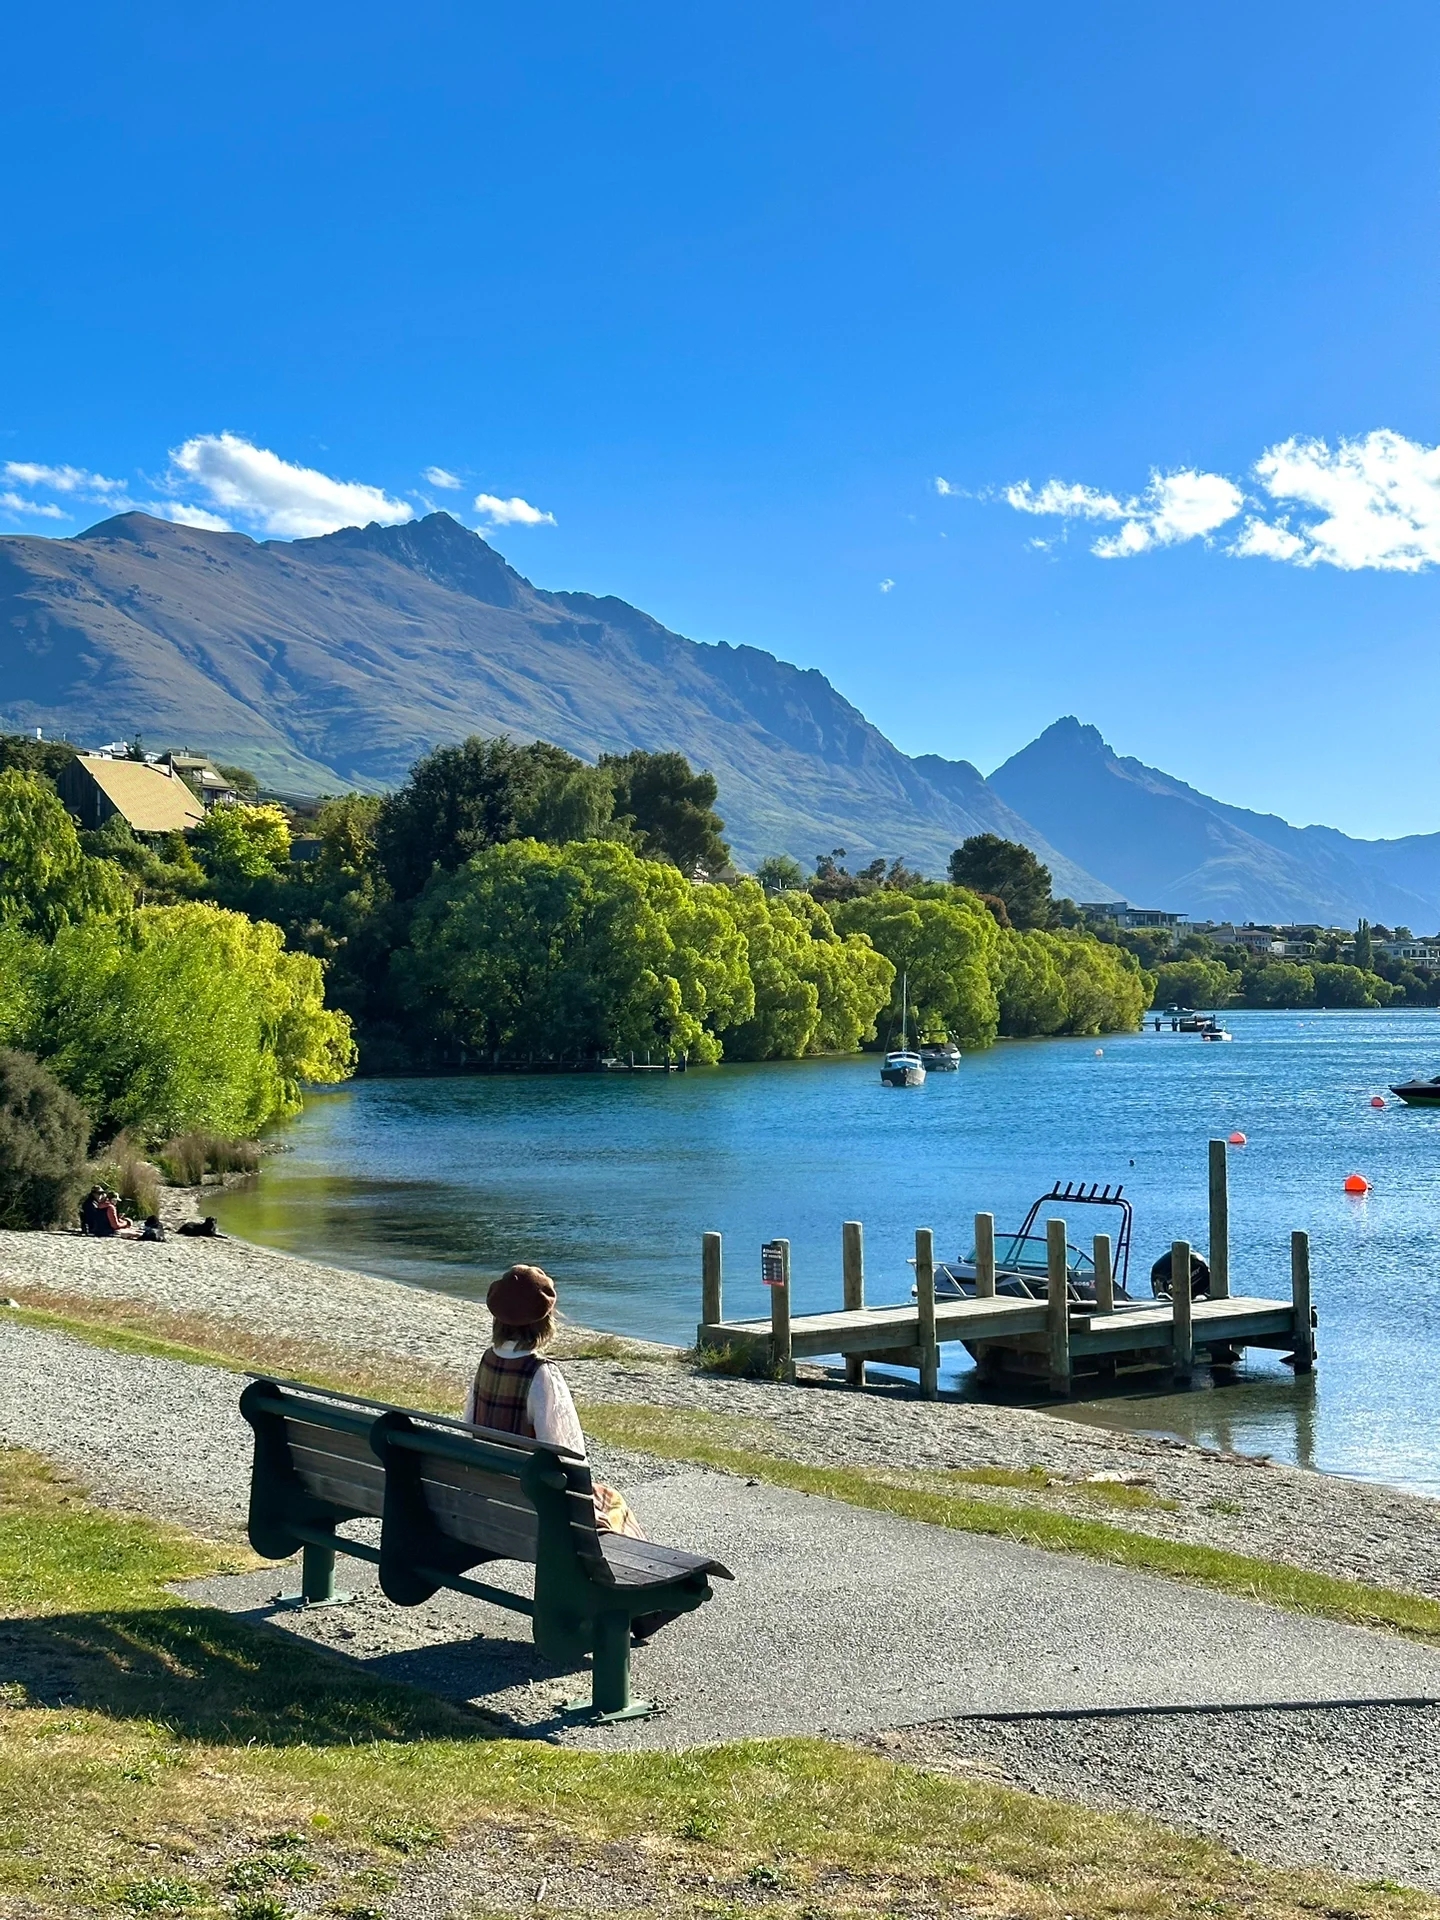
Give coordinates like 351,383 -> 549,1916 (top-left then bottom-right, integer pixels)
0,513 -> 1114,899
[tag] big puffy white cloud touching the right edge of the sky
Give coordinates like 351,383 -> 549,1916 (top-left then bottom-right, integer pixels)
1236,428 -> 1440,574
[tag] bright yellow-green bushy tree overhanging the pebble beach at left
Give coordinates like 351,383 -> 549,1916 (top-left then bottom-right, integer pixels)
29,902 -> 355,1140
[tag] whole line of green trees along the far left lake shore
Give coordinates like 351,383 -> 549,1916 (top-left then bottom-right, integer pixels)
0,737 -> 1154,1219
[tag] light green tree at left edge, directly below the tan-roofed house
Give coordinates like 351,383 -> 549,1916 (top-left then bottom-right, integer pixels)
0,768 -> 131,937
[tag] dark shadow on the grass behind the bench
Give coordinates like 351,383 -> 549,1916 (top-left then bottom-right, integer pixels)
0,1605 -> 541,1747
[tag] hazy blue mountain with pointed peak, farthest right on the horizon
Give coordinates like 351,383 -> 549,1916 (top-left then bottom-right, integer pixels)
989,718 -> 1440,931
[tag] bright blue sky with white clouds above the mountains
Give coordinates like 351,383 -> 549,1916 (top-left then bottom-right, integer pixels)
0,0 -> 1440,833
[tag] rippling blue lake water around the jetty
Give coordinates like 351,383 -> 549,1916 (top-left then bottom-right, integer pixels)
217,1012 -> 1440,1494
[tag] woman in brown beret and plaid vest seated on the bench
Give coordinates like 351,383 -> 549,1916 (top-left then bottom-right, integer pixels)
461,1267 -> 645,1540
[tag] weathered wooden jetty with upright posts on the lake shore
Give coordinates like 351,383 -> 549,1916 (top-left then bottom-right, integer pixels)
697,1140 -> 1315,1400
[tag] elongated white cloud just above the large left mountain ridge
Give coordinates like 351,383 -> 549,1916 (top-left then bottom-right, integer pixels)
171,434 -> 415,540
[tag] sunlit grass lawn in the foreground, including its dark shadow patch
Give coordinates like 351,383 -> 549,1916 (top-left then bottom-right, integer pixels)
0,1452 -> 1440,1920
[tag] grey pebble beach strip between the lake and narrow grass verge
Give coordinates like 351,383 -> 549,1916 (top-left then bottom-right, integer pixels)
0,1233 -> 1440,1597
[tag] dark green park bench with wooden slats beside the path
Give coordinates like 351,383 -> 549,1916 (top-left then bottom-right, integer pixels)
240,1377 -> 733,1720
